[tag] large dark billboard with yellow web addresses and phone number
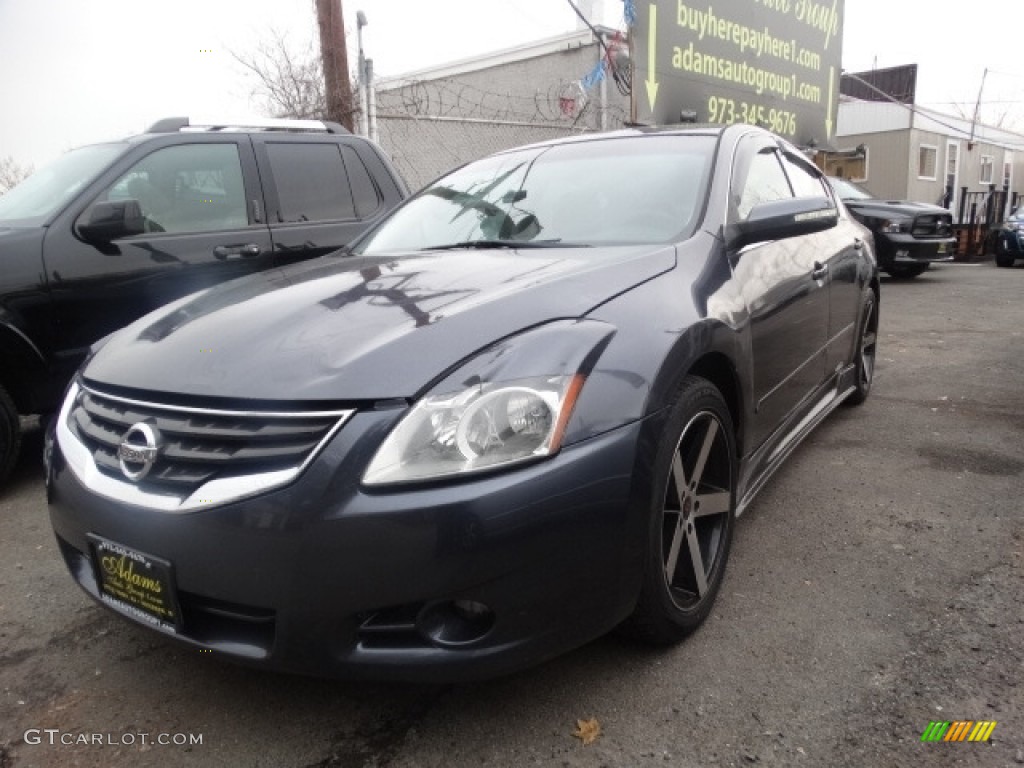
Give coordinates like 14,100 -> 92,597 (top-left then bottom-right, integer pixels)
633,0 -> 843,146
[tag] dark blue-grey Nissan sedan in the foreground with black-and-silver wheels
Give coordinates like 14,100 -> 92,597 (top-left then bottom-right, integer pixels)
45,125 -> 879,681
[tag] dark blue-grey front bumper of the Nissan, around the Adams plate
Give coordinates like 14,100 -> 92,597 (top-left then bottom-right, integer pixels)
48,412 -> 650,681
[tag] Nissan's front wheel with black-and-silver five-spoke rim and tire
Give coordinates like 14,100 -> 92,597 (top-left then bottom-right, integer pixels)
625,376 -> 736,644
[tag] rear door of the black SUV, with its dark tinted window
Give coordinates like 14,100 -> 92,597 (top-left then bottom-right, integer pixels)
254,134 -> 394,265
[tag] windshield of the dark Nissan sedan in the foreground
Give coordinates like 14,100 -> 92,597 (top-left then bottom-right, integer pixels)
352,135 -> 715,255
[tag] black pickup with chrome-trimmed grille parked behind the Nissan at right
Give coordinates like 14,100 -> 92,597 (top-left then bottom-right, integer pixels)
828,177 -> 956,278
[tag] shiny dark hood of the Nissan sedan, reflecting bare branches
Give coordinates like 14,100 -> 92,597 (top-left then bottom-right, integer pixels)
83,246 -> 676,401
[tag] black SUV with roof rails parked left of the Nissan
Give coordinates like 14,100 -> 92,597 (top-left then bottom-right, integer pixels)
0,118 -> 409,482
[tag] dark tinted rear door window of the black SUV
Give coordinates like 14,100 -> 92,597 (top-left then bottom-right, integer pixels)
266,142 -> 355,222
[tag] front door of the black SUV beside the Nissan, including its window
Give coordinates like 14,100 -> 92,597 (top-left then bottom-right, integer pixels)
43,134 -> 272,366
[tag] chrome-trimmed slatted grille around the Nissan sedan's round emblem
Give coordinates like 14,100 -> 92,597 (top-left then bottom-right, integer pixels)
61,387 -> 352,510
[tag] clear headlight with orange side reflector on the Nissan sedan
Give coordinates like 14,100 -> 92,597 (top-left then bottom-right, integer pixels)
362,321 -> 612,485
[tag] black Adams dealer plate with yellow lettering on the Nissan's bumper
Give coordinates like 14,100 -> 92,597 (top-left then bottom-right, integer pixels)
89,536 -> 181,632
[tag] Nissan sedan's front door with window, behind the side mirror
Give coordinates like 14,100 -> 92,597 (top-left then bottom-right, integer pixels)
729,137 -> 828,445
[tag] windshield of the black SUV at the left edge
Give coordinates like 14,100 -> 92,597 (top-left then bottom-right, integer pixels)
0,143 -> 126,226
